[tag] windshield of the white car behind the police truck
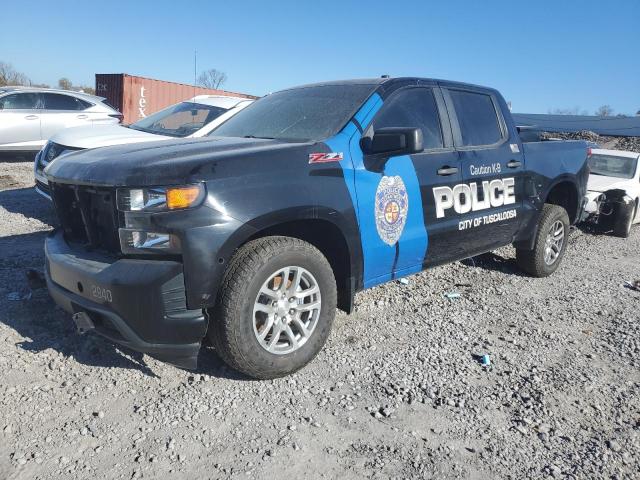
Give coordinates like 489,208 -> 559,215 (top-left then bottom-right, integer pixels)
129,102 -> 227,137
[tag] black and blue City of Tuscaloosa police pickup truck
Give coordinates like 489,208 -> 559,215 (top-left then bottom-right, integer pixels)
45,78 -> 588,378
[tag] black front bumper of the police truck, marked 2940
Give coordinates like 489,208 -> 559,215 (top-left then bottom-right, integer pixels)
45,231 -> 207,369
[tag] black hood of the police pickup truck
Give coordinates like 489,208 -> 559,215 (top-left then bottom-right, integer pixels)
44,137 -> 313,186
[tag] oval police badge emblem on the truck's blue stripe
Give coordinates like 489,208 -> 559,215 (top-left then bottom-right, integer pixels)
375,176 -> 409,245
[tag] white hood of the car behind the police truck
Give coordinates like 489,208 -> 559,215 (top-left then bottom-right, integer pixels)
50,125 -> 174,148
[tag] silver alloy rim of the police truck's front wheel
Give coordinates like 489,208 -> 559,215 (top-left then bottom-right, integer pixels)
252,266 -> 322,355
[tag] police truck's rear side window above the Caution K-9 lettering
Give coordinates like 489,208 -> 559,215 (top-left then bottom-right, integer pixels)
449,90 -> 502,146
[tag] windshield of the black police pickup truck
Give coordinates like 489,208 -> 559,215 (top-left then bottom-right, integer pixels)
209,85 -> 376,142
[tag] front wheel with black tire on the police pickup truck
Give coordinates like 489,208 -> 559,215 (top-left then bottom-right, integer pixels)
207,236 -> 337,379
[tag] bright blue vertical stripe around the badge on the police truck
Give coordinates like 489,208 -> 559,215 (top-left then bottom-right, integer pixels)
325,93 -> 428,288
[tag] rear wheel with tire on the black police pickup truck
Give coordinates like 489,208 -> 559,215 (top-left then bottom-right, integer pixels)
516,203 -> 569,277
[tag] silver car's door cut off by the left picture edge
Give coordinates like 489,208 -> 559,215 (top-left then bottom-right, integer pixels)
0,92 -> 43,150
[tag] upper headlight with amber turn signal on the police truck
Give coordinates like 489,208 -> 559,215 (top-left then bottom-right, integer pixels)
116,183 -> 205,212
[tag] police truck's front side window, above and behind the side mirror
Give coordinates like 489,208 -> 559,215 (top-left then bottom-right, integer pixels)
373,88 -> 443,149
